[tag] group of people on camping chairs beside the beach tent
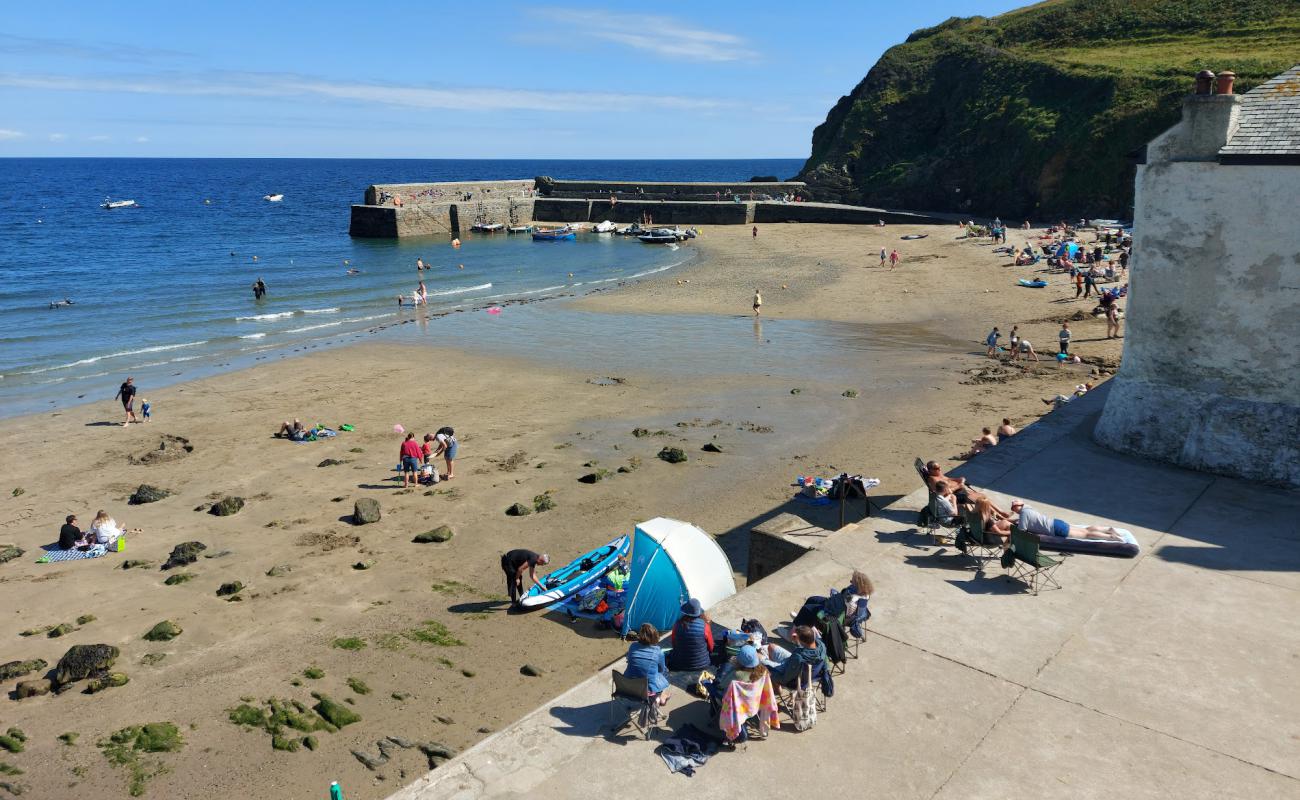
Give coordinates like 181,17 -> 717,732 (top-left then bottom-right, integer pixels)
624,571 -> 872,743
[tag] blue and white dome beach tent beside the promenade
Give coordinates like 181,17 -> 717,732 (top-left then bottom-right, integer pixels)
623,516 -> 736,633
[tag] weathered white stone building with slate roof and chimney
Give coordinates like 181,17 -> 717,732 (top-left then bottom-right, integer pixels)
1095,65 -> 1300,487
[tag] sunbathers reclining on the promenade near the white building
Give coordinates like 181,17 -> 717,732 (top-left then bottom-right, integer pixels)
923,460 -> 1127,549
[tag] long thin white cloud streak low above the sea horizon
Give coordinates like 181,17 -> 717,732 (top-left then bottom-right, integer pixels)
0,73 -> 732,112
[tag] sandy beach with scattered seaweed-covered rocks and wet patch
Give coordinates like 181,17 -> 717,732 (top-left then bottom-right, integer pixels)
0,225 -> 1119,800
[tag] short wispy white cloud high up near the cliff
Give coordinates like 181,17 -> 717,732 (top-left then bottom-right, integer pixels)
532,8 -> 758,61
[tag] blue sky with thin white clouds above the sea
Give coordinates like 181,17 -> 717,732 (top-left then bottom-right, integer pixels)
0,0 -> 1022,159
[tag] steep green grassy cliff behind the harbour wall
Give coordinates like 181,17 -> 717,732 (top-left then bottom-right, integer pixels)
800,0 -> 1300,219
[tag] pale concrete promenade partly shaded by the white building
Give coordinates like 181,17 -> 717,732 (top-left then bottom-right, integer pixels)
393,388 -> 1300,800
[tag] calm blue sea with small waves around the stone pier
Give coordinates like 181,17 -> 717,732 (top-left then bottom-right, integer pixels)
0,159 -> 802,415
